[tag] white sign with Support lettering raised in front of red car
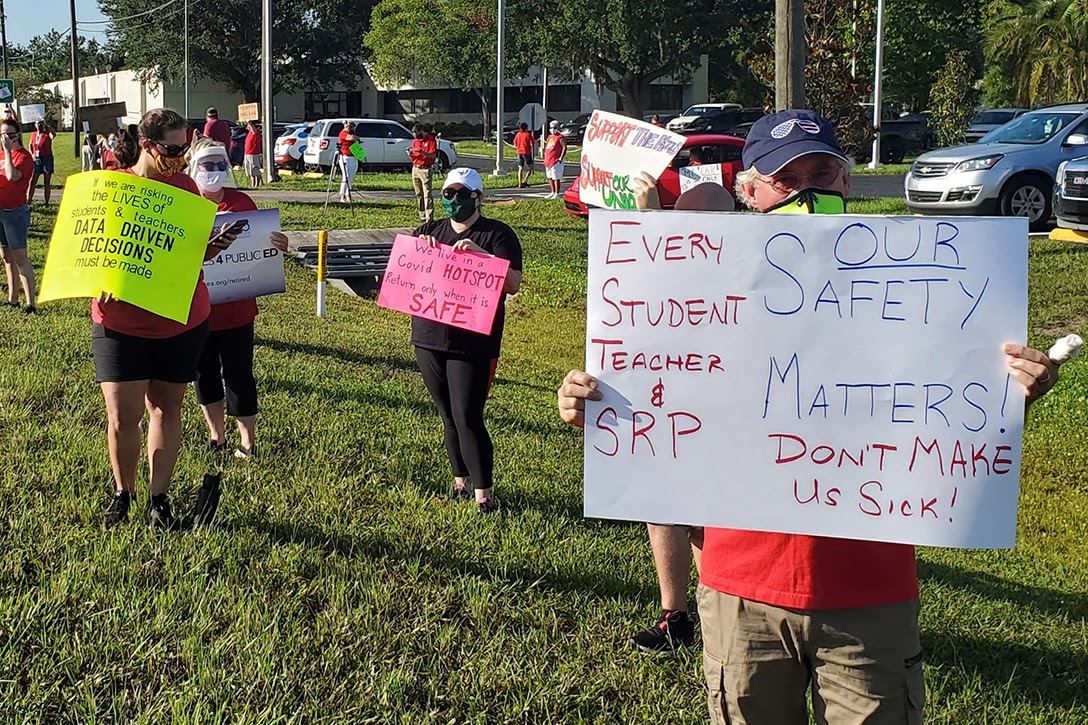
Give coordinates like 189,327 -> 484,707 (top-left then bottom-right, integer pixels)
578,111 -> 684,209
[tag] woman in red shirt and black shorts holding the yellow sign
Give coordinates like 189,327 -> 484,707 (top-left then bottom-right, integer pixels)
90,108 -> 241,529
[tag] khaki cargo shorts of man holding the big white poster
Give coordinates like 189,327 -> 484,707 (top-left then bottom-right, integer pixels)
698,586 -> 926,725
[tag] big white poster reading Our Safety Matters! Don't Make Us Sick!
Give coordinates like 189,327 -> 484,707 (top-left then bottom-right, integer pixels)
585,210 -> 1027,548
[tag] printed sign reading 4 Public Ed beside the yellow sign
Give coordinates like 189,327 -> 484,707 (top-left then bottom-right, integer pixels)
203,209 -> 286,305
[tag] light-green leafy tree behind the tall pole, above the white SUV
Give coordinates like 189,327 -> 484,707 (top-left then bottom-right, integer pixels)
363,0 -> 528,138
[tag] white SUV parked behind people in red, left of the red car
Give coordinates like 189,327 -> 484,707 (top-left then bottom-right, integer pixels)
302,119 -> 457,173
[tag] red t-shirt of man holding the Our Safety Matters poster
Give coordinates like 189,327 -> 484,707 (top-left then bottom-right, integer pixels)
700,528 -> 918,610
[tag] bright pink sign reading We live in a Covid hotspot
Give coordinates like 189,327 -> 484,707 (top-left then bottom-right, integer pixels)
378,234 -> 510,335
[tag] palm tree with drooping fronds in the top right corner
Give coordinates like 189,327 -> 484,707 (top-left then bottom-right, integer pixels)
986,0 -> 1088,107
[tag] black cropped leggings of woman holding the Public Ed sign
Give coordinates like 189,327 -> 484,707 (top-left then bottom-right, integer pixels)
196,322 -> 257,418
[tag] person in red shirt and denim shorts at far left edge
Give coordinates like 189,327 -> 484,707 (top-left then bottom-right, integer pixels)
0,120 -> 35,314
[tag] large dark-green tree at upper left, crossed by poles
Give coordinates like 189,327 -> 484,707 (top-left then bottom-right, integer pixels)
99,0 -> 370,103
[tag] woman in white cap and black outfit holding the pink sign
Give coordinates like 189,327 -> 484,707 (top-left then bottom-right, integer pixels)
411,169 -> 521,514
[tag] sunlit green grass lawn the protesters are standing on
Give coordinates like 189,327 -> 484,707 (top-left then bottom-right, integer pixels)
0,201 -> 1088,725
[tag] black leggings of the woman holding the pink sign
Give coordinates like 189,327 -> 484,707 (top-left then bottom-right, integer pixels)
416,347 -> 495,489
